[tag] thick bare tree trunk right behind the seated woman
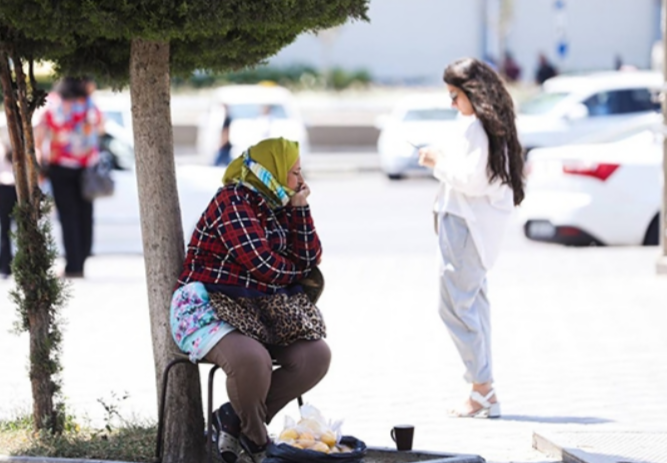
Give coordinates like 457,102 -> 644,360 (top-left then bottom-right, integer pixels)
130,39 -> 204,463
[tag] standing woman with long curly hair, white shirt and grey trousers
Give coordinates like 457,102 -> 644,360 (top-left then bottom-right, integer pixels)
419,58 -> 524,418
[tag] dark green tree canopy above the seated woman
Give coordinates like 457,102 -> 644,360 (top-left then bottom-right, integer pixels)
0,0 -> 369,86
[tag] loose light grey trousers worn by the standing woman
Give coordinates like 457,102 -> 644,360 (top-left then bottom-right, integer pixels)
438,213 -> 493,383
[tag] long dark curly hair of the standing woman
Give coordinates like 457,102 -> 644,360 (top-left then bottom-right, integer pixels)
444,58 -> 525,206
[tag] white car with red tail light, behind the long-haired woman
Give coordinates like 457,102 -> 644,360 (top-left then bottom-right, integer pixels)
519,123 -> 663,245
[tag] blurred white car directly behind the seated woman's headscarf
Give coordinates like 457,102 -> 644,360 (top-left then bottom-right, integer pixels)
197,85 -> 309,160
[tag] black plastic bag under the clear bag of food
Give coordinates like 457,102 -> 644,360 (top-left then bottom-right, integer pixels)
264,436 -> 366,463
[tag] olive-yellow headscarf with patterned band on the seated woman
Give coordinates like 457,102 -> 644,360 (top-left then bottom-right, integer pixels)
222,138 -> 299,208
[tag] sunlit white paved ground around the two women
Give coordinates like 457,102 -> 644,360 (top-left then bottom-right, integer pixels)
0,175 -> 667,462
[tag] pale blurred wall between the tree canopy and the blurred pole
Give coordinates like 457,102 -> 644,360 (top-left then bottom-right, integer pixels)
270,0 -> 482,84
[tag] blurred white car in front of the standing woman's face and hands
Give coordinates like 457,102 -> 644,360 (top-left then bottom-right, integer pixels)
376,92 -> 458,180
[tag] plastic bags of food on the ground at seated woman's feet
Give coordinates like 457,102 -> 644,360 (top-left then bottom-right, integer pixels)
265,404 -> 366,463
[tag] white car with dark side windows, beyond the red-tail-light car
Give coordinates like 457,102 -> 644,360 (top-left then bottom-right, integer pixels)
517,71 -> 663,151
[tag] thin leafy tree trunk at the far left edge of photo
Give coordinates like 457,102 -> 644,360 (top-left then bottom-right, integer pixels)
0,52 -> 63,433
